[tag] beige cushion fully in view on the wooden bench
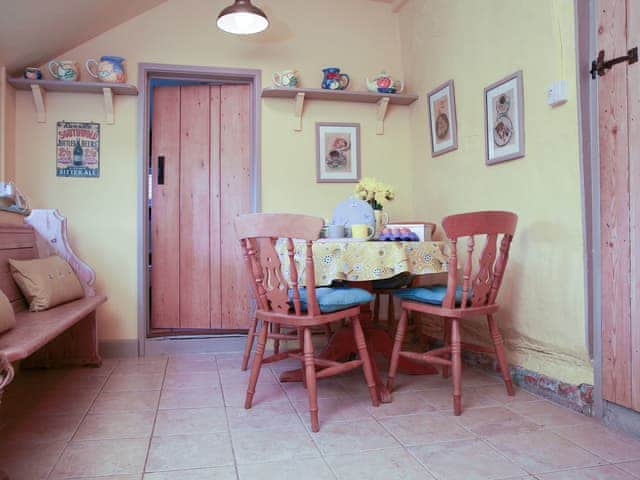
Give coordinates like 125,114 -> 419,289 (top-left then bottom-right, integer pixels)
9,255 -> 84,312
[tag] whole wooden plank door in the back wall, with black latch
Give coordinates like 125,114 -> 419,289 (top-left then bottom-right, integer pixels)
151,85 -> 252,333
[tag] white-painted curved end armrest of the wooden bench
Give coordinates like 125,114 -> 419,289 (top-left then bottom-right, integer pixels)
25,209 -> 96,297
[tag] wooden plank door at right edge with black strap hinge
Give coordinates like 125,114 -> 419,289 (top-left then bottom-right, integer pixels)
598,0 -> 640,411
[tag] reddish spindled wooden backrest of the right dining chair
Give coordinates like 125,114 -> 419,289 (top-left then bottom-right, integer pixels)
442,211 -> 518,308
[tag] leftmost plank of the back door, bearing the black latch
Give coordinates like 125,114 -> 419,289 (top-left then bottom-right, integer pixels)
151,87 -> 180,328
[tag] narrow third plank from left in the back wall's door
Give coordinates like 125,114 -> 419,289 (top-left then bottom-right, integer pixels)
209,87 -> 223,328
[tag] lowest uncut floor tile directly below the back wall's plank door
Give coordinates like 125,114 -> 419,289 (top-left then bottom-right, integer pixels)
146,432 -> 233,472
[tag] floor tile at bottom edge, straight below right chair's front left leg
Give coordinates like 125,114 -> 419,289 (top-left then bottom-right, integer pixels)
409,439 -> 526,480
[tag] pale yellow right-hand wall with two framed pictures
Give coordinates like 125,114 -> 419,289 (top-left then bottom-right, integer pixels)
399,0 -> 593,383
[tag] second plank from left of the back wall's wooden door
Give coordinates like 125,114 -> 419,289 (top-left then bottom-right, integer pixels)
180,86 -> 211,328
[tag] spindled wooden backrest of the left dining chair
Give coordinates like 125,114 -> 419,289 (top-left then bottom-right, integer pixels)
235,213 -> 324,316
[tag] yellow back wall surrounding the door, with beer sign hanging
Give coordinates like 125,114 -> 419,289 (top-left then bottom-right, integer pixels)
16,0 -> 413,340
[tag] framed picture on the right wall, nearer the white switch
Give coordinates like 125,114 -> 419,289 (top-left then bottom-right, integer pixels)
484,71 -> 524,165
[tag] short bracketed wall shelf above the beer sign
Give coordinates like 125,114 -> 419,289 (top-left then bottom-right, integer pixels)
8,78 -> 138,123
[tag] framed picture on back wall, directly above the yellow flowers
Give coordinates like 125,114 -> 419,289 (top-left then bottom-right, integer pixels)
316,123 -> 360,183
